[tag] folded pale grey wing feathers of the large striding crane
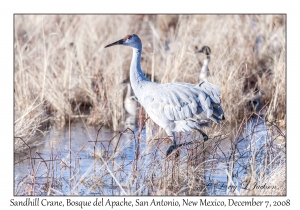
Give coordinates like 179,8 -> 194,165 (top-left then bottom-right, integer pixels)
141,82 -> 224,130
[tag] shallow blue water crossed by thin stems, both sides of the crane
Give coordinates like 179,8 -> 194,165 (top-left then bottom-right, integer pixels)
14,118 -> 286,195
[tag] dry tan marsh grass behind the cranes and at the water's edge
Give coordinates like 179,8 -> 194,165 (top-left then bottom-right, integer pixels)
14,15 -> 286,195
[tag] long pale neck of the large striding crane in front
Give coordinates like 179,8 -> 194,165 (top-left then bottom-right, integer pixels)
130,47 -> 149,99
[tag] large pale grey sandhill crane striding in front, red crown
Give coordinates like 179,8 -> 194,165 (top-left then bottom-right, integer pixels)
105,34 -> 225,156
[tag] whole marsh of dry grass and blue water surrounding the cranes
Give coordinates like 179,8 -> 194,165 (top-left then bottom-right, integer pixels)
14,15 -> 286,195
